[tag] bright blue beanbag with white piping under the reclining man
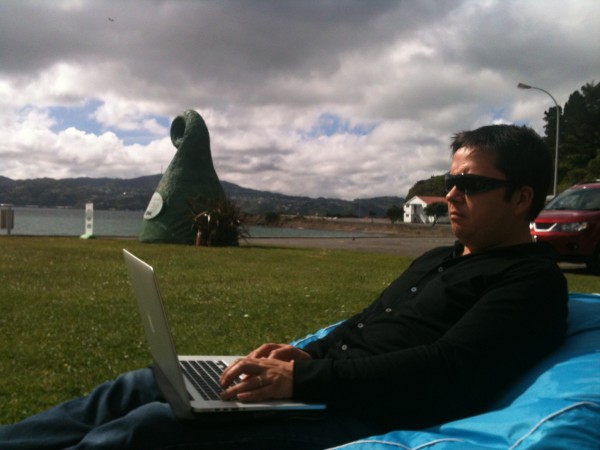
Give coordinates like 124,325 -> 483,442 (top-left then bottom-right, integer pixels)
294,294 -> 600,450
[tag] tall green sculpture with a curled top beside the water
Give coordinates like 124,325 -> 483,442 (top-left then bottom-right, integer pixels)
139,110 -> 226,245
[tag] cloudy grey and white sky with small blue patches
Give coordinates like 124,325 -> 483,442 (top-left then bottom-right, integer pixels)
0,0 -> 600,199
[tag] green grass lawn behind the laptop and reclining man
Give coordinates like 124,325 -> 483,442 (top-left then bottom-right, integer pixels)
0,236 -> 600,423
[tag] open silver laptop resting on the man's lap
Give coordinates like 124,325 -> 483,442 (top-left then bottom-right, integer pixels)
123,249 -> 325,418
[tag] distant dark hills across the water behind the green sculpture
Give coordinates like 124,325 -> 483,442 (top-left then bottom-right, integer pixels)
0,175 -> 404,217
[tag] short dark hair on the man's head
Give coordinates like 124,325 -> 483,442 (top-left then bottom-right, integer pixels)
450,125 -> 552,220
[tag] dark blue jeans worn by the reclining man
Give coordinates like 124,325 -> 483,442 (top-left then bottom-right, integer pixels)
0,369 -> 383,450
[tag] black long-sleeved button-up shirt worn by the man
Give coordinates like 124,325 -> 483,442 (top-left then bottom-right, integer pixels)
294,244 -> 568,426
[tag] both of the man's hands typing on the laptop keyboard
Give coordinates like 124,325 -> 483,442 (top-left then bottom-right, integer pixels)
221,344 -> 311,402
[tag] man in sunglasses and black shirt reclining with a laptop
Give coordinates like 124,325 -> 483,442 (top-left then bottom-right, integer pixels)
0,125 -> 567,450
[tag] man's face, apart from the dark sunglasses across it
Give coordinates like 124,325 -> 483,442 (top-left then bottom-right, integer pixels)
446,147 -> 528,254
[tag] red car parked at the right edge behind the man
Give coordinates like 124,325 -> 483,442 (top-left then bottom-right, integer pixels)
531,180 -> 600,273
